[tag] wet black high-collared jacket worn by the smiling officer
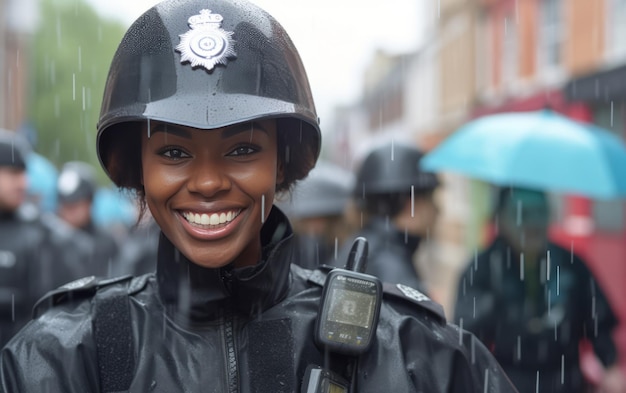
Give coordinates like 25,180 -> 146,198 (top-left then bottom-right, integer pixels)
0,209 -> 515,393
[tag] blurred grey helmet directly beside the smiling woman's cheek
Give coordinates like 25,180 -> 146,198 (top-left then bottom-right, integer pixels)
277,162 -> 354,219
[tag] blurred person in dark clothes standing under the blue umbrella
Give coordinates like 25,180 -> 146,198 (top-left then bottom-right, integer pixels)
454,187 -> 626,393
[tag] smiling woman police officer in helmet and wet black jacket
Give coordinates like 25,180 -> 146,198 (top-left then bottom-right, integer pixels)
1,0 -> 514,393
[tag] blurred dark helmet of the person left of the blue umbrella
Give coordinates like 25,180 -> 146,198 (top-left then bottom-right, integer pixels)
354,144 -> 439,200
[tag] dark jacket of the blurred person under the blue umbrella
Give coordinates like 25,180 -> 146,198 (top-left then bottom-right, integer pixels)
454,237 -> 617,393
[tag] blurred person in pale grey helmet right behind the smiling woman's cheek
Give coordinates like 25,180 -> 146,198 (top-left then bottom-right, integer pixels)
277,161 -> 354,269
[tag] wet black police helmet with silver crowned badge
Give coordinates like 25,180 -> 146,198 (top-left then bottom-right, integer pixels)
97,0 -> 321,191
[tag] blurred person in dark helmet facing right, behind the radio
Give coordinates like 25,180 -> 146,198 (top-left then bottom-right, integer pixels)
330,143 -> 440,293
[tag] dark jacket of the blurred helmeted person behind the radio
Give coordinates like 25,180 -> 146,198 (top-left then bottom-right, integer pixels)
328,217 -> 427,293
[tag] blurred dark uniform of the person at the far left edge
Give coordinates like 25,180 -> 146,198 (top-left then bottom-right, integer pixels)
0,205 -> 89,347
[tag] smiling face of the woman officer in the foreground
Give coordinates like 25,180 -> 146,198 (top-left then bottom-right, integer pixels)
142,120 -> 282,268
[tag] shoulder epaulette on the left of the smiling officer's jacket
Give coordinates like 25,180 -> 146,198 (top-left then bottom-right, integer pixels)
33,275 -> 133,318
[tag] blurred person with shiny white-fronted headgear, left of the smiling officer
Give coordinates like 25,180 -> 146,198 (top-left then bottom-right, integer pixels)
57,161 -> 119,277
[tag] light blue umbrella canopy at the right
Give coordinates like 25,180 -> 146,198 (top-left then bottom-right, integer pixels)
422,109 -> 626,199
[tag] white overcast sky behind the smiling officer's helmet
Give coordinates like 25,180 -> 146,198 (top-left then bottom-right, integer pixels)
87,0 -> 428,128
